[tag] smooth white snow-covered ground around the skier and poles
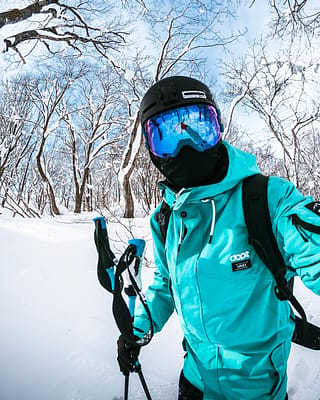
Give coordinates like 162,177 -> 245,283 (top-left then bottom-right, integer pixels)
0,210 -> 320,400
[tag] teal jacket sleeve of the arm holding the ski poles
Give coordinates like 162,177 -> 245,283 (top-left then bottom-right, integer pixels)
134,205 -> 174,337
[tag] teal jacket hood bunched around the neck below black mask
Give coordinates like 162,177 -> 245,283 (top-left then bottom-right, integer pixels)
159,141 -> 261,204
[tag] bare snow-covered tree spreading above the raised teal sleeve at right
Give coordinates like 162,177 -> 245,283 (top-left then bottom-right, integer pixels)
225,43 -> 320,188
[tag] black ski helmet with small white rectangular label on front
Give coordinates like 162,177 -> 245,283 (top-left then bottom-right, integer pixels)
139,76 -> 223,132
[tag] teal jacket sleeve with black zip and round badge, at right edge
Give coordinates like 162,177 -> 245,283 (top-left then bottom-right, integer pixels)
268,177 -> 320,295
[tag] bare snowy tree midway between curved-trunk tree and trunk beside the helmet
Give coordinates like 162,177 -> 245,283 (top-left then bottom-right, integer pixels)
62,71 -> 123,213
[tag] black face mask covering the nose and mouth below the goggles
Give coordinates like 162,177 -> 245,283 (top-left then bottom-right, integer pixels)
150,142 -> 228,190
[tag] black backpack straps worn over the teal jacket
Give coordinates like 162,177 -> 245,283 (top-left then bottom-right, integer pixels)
155,174 -> 320,350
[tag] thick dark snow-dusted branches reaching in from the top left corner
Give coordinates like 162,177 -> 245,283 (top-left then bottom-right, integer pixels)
0,0 -> 126,63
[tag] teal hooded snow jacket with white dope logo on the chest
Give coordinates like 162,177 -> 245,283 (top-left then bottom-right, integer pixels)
134,142 -> 320,400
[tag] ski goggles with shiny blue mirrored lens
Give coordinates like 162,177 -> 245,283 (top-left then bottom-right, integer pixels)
142,104 -> 221,158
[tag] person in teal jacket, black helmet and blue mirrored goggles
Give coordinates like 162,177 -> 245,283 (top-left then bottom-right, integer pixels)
118,76 -> 320,400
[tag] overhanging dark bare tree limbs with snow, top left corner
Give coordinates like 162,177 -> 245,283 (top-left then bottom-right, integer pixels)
0,0 -> 126,63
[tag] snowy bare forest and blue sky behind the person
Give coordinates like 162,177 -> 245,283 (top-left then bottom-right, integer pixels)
0,0 -> 320,218
